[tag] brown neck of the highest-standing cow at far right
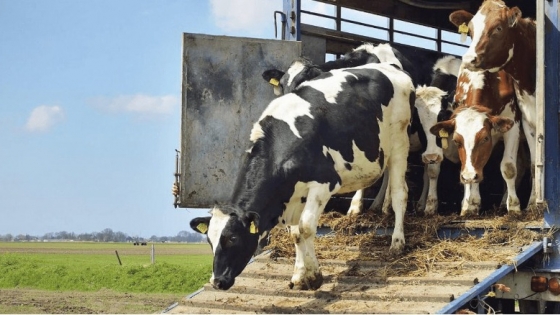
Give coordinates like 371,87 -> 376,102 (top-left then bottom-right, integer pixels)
503,19 -> 537,95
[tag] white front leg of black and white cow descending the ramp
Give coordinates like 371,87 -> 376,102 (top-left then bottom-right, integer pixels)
290,184 -> 332,290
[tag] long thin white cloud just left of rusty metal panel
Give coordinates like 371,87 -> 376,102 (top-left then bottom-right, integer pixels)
92,94 -> 179,115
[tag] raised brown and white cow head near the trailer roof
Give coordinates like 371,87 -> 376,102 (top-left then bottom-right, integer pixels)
449,0 -> 521,72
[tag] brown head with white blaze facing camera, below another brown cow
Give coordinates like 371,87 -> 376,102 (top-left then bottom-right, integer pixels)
430,105 -> 513,184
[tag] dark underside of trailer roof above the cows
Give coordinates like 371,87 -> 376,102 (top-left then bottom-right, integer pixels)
316,0 -> 536,31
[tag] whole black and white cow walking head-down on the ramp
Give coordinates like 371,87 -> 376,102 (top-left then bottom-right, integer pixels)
191,63 -> 414,290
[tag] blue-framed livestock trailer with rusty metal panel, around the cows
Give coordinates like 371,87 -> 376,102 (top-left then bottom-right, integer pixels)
175,0 -> 560,313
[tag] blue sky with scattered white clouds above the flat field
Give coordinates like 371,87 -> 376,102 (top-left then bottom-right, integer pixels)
0,0 -> 464,237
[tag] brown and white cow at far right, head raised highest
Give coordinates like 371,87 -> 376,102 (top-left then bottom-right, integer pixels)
449,0 -> 536,211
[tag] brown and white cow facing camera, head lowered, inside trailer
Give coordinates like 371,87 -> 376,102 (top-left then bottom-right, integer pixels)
431,68 -> 521,215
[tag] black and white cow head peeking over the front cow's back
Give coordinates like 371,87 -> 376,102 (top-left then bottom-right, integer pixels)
262,58 -> 323,96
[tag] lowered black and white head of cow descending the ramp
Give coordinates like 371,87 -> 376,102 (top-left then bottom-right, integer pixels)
190,207 -> 259,290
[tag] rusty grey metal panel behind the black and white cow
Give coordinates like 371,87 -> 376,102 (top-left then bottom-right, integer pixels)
178,33 -> 301,208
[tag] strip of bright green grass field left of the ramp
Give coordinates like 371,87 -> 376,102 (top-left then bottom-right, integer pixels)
0,242 -> 212,293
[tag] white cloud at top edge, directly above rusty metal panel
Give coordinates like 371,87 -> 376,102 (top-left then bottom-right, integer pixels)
210,0 -> 282,34
